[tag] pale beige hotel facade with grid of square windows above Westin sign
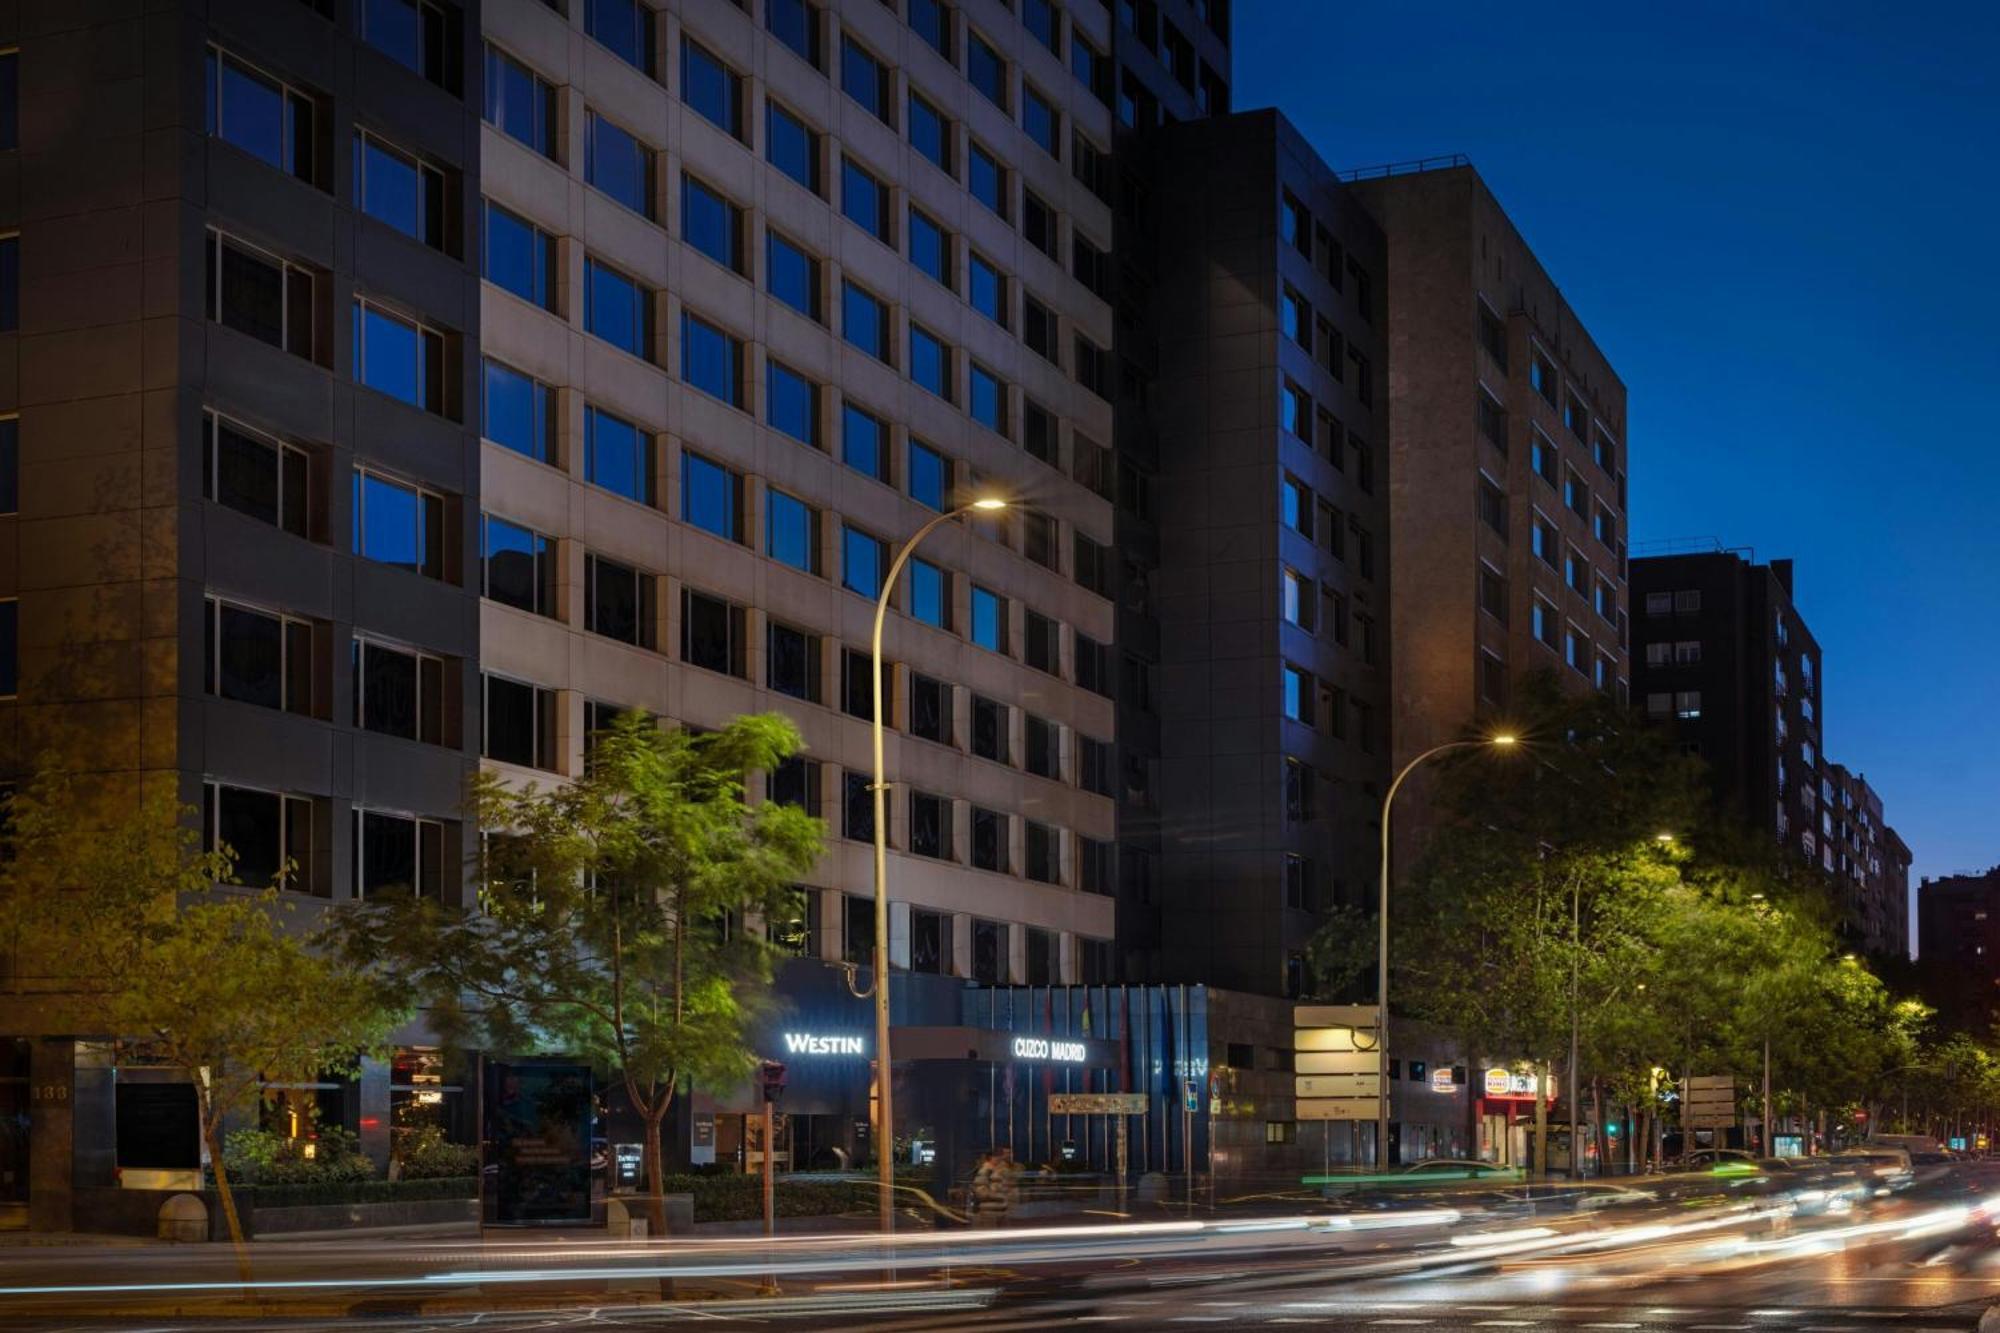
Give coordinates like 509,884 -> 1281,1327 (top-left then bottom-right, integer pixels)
478,0 -> 1116,985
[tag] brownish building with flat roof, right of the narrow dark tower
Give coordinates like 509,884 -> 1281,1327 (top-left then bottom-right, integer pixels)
1348,158 -> 1630,768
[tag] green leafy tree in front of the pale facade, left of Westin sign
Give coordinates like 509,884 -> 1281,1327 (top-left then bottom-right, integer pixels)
348,713 -> 824,1235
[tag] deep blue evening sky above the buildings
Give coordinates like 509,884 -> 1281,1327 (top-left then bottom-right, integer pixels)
1234,0 -> 2000,924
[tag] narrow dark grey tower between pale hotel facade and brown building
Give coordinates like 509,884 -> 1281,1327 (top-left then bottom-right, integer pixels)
1148,110 -> 1390,995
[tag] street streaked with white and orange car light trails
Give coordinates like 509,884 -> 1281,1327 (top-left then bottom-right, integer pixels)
0,1165 -> 2000,1333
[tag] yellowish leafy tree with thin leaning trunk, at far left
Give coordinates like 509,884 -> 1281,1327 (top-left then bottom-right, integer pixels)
0,771 -> 400,1281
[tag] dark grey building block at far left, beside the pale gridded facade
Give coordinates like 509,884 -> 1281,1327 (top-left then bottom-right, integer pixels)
0,0 -> 480,1229
